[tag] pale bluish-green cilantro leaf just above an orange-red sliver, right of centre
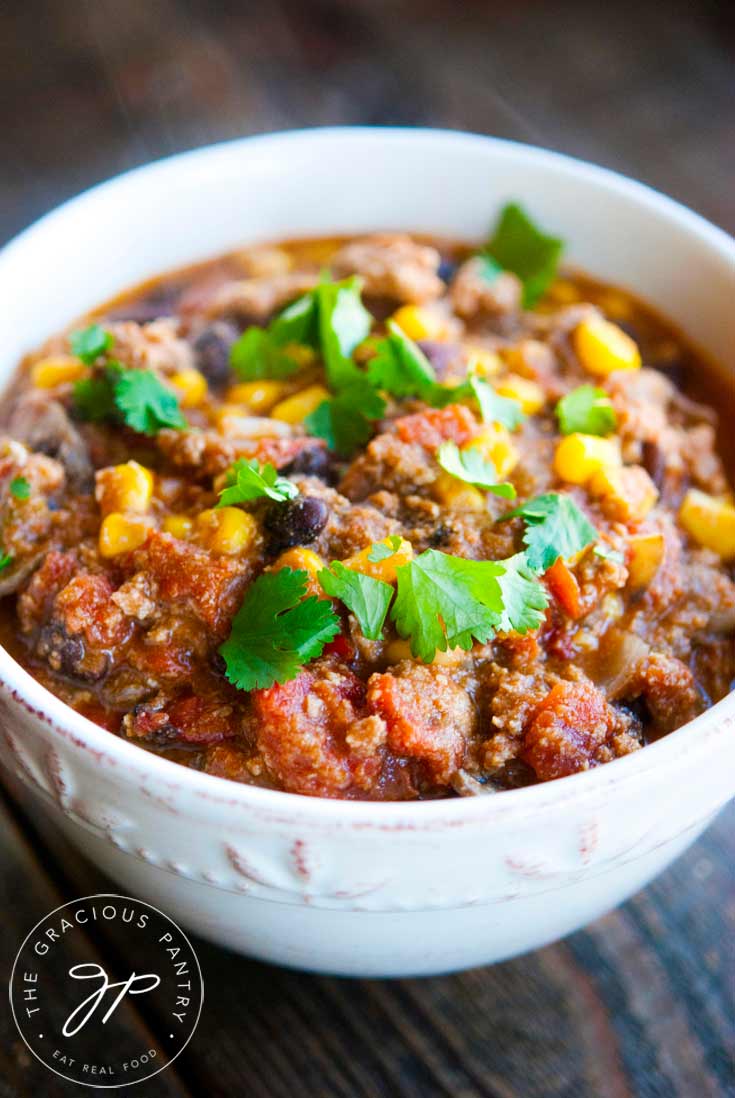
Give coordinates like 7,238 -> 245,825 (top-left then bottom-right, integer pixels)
498,492 -> 598,572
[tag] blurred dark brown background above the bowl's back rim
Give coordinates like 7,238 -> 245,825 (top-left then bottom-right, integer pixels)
0,0 -> 735,240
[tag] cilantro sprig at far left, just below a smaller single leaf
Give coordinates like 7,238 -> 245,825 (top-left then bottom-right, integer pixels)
74,362 -> 187,435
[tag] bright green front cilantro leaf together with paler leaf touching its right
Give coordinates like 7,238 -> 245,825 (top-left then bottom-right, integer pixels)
391,549 -> 546,663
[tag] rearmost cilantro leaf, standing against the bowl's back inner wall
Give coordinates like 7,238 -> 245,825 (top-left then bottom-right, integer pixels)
483,202 -> 564,309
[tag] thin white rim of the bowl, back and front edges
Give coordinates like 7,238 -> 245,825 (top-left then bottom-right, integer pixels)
0,126 -> 735,829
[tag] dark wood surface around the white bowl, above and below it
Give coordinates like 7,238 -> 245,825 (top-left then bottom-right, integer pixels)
0,0 -> 735,1098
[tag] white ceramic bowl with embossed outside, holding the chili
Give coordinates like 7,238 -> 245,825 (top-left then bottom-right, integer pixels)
0,130 -> 735,975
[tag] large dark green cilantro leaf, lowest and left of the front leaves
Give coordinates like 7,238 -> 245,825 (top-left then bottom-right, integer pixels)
220,568 -> 339,690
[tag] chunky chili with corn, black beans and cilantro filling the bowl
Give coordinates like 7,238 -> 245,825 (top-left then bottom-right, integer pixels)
0,205 -> 735,799
